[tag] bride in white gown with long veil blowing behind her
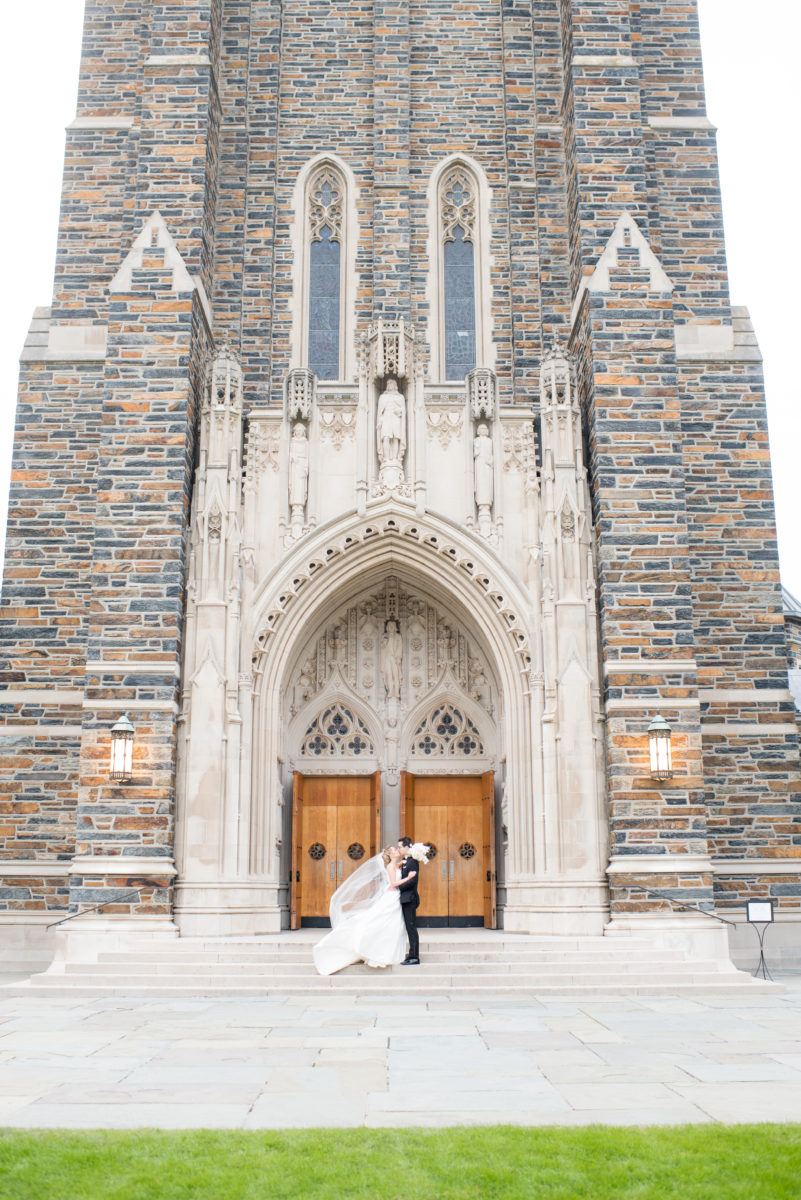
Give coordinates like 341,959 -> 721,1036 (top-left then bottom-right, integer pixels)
312,846 -> 416,974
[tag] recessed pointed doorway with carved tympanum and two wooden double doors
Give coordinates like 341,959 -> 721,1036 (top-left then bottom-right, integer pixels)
284,575 -> 501,928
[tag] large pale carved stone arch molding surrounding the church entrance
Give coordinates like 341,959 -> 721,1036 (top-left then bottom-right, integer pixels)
242,502 -> 556,928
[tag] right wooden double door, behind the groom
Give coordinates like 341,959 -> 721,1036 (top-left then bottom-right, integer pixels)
401,772 -> 495,929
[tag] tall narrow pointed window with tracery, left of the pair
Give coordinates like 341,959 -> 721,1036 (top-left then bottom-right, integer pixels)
306,163 -> 345,379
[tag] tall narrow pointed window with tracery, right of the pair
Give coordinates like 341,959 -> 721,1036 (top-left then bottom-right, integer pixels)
439,163 -> 477,379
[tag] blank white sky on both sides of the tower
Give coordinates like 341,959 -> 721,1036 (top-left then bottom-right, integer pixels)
0,0 -> 801,598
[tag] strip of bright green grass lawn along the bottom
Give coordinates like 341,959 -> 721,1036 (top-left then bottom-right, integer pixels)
0,1124 -> 801,1200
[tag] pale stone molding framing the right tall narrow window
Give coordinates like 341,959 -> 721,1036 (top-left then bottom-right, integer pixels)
426,154 -> 495,383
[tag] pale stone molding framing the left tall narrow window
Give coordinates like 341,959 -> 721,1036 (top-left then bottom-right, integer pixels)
289,151 -> 359,382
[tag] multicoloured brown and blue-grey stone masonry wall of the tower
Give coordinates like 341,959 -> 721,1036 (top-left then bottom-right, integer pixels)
0,0 -> 801,936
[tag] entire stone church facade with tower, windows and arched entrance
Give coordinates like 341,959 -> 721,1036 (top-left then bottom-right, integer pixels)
0,0 -> 801,953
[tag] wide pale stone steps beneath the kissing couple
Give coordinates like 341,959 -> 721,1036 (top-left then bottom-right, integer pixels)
0,929 -> 783,997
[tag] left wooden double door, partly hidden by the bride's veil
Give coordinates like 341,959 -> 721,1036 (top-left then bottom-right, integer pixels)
290,772 -> 381,929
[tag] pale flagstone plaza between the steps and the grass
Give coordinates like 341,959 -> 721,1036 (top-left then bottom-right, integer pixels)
0,976 -> 801,1129
